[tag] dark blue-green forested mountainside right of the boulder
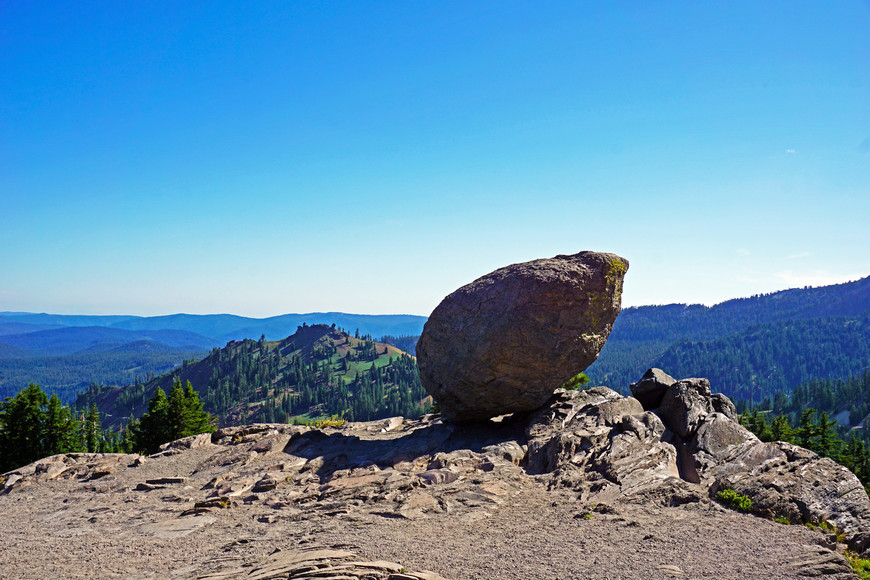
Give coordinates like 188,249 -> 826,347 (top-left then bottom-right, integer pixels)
587,278 -> 870,401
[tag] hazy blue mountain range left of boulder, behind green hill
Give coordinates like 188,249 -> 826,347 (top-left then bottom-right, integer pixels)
0,312 -> 426,401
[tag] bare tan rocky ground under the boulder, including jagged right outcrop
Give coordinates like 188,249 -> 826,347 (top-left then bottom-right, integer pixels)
0,380 -> 870,580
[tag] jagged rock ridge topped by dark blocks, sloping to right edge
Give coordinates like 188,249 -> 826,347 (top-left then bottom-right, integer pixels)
631,369 -> 870,552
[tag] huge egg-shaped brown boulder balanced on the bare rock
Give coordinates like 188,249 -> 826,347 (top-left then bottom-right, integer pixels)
417,252 -> 628,422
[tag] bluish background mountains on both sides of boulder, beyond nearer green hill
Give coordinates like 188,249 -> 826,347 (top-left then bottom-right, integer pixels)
0,277 -> 870,408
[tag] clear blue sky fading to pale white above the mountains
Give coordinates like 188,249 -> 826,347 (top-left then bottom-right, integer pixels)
0,0 -> 870,316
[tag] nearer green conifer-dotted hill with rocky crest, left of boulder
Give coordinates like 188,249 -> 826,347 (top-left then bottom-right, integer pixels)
76,324 -> 427,425
